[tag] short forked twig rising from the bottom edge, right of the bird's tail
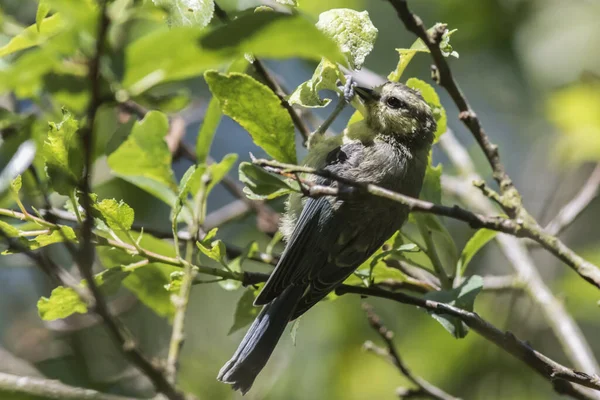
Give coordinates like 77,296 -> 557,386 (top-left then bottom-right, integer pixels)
363,303 -> 459,400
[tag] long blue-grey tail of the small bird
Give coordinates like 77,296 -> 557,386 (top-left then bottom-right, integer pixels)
217,286 -> 304,394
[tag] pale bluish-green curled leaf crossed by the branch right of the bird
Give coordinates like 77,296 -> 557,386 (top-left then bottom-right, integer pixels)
425,275 -> 483,339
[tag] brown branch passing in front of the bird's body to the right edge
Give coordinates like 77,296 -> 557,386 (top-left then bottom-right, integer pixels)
254,159 -> 600,288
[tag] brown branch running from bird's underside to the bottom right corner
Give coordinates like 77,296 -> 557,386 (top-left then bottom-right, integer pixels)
335,285 -> 600,399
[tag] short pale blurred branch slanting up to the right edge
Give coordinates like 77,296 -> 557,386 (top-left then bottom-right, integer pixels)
544,164 -> 600,236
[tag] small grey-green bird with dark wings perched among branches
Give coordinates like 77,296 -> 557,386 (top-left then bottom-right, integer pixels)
217,82 -> 436,394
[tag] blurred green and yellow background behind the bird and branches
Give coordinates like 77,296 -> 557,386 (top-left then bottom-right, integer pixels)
0,0 -> 600,400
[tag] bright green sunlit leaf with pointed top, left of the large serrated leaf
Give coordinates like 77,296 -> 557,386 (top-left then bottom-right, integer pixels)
108,111 -> 177,206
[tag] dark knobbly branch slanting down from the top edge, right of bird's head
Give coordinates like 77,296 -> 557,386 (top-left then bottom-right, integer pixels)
389,0 -> 521,217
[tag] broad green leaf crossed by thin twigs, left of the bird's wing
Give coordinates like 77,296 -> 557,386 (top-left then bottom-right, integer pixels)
97,232 -> 181,318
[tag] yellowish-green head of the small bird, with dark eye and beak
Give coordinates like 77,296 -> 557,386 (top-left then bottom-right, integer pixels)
355,82 -> 436,143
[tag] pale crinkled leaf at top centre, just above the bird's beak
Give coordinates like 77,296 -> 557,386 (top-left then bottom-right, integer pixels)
317,8 -> 378,69
